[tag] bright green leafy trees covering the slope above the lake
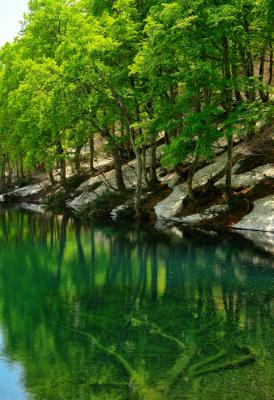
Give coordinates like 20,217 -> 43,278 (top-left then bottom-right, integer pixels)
0,0 -> 274,216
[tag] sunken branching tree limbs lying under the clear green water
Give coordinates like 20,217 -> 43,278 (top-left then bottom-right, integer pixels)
45,319 -> 256,400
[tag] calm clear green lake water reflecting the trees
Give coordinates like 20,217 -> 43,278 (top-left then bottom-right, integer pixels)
0,206 -> 274,400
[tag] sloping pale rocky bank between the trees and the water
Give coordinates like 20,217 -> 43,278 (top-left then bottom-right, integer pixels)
0,138 -> 274,251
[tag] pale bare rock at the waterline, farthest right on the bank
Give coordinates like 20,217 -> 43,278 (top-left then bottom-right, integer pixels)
233,195 -> 274,232
